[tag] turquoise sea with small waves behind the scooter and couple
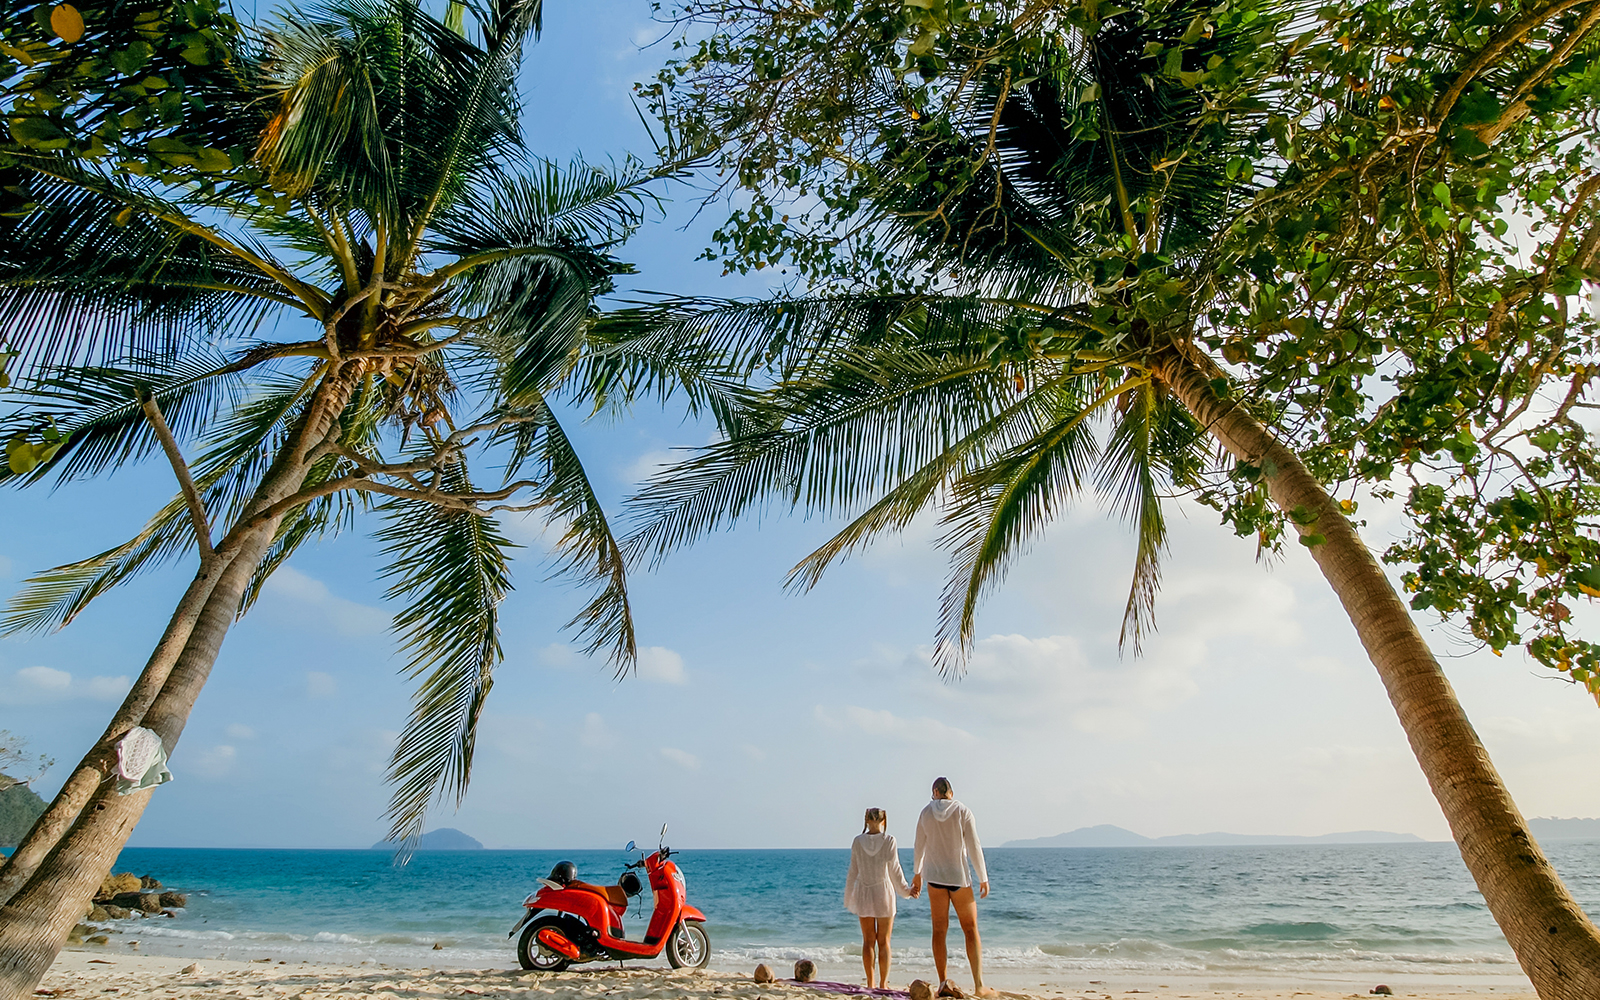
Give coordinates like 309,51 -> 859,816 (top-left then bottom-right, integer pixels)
75,842 -> 1600,984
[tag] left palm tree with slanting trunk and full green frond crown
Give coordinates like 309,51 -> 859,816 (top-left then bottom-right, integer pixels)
0,0 -> 681,1000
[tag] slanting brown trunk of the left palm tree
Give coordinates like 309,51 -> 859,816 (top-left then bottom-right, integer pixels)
0,368 -> 354,1000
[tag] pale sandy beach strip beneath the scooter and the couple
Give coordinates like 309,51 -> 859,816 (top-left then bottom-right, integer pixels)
37,949 -> 1536,1000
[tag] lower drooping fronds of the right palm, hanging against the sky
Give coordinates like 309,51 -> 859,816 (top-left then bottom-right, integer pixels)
602,296 -> 1200,672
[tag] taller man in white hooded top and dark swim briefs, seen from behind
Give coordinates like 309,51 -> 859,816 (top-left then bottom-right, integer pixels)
910,778 -> 995,997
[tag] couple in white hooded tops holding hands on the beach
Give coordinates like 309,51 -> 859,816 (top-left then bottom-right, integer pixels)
845,778 -> 994,997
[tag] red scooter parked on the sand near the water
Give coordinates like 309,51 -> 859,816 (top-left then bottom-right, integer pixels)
507,826 -> 710,973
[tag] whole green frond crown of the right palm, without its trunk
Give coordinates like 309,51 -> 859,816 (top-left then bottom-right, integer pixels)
608,3 -> 1267,672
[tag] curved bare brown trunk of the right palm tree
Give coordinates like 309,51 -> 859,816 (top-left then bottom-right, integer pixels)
1154,339 -> 1600,1000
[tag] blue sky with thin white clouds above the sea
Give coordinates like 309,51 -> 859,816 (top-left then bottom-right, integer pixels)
0,0 -> 1600,848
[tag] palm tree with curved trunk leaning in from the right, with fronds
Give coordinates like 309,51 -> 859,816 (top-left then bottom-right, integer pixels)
606,5 -> 1600,1000
